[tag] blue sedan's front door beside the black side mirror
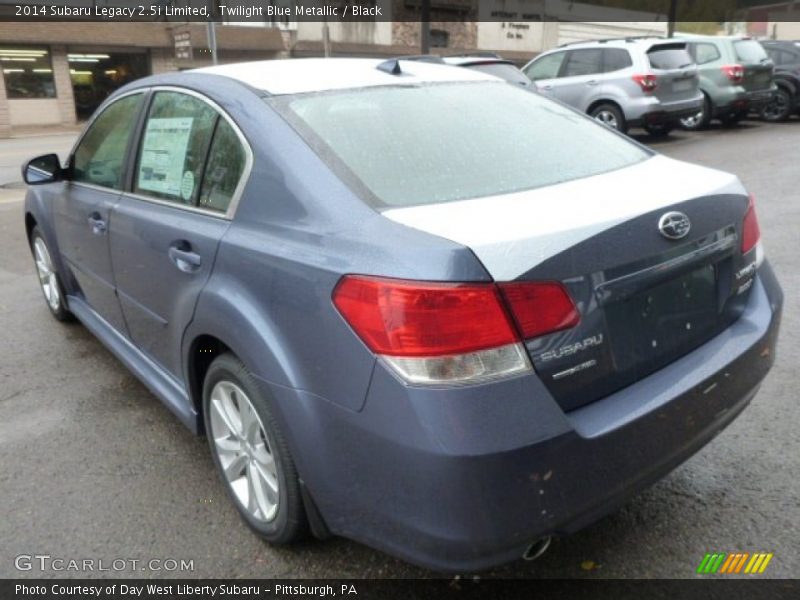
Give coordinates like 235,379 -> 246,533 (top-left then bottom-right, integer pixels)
54,93 -> 144,335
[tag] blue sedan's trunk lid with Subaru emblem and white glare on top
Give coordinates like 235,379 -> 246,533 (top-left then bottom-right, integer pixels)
383,157 -> 754,410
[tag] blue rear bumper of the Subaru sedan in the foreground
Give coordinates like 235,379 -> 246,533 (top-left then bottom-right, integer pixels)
265,263 -> 783,571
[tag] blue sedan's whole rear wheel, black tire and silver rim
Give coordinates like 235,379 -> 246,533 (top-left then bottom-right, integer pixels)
203,354 -> 307,544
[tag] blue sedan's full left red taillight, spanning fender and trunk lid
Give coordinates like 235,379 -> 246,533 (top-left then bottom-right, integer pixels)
333,275 -> 580,357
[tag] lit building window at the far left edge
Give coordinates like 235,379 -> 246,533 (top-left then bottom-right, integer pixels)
0,46 -> 56,99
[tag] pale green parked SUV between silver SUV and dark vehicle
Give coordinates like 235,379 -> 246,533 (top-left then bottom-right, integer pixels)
680,36 -> 776,130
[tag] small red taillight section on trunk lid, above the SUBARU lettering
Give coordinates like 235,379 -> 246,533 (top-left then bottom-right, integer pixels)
498,281 -> 580,339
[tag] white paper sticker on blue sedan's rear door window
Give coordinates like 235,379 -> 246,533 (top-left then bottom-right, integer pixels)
138,117 -> 194,197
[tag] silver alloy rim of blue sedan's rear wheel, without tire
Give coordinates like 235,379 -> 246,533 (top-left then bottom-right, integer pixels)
209,380 -> 279,523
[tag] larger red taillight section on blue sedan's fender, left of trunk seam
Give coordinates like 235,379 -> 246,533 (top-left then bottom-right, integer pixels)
333,275 -> 518,356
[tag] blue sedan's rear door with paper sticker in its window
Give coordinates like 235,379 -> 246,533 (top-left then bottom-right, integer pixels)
110,90 -> 251,377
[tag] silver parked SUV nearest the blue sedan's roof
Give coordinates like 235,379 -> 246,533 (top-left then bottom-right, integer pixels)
522,38 -> 703,135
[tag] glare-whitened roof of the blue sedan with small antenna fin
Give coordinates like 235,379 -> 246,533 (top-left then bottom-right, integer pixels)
191,58 -> 497,95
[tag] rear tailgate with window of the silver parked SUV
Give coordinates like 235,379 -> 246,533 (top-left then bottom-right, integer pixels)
646,42 -> 699,106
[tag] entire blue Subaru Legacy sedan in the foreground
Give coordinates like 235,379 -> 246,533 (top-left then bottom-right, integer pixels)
25,59 -> 782,570
